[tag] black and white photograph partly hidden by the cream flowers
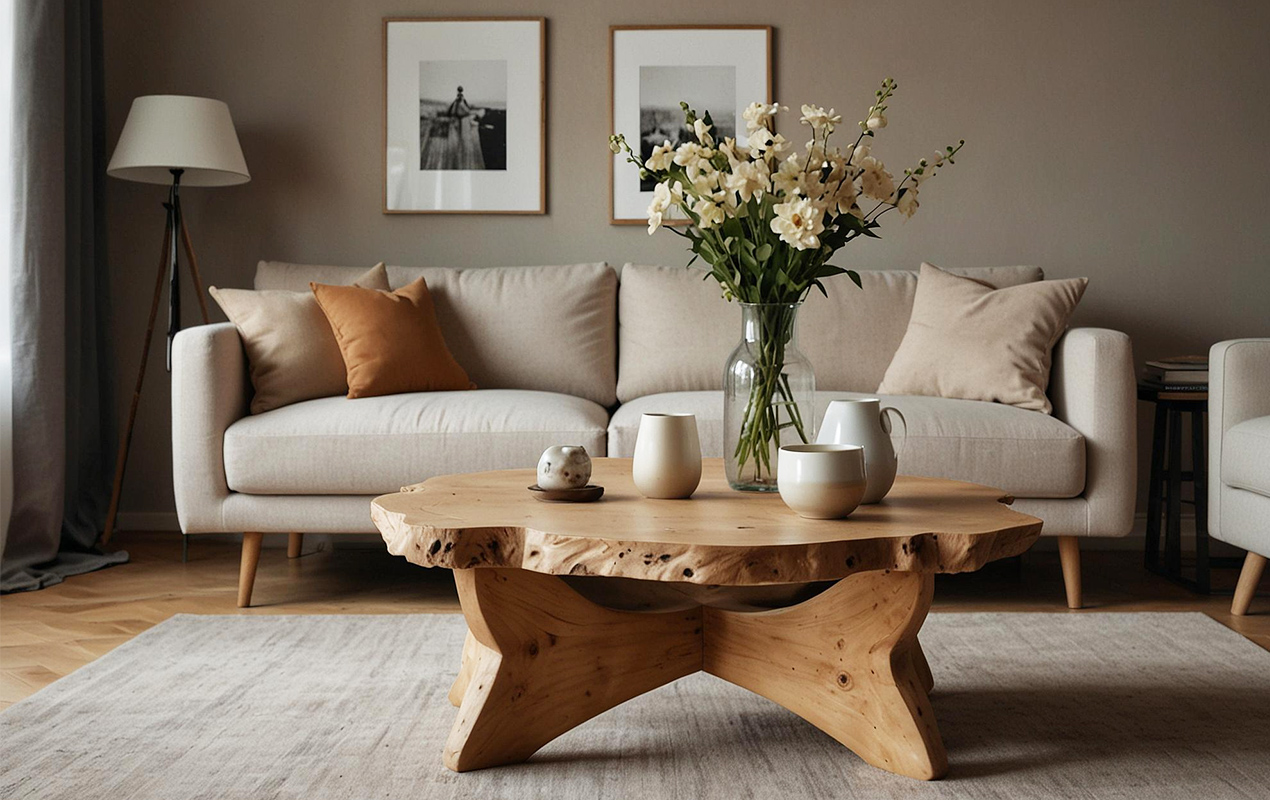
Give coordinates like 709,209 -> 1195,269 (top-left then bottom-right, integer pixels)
639,66 -> 737,192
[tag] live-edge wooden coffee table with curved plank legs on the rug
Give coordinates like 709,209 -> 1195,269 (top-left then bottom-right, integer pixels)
372,458 -> 1041,780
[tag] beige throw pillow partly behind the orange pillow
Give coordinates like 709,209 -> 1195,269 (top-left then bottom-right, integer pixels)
208,263 -> 389,414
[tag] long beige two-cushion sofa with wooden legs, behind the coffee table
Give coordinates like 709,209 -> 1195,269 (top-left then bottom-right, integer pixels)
173,263 -> 1135,607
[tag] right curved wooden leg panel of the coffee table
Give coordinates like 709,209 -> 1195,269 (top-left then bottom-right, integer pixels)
702,571 -> 947,780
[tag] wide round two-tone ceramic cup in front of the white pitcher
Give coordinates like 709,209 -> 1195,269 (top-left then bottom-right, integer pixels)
776,444 -> 869,519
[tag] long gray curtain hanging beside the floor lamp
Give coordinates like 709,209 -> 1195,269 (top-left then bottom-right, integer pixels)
0,0 -> 128,592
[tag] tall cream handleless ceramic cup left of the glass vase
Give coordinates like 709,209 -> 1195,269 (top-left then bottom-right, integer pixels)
631,414 -> 701,500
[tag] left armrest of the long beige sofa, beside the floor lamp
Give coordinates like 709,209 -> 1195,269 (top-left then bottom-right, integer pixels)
171,323 -> 250,533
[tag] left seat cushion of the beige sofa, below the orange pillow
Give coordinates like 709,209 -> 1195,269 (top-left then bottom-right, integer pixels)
225,389 -> 608,495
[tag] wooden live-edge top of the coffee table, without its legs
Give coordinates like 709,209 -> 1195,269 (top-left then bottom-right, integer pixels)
371,458 -> 1041,585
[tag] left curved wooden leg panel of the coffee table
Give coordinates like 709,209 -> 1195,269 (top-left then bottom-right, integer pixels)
445,569 -> 701,772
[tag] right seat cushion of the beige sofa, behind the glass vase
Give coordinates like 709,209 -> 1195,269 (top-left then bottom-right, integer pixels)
608,391 -> 1085,498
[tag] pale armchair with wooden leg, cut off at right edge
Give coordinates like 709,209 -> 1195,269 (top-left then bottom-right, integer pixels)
1208,339 -> 1270,615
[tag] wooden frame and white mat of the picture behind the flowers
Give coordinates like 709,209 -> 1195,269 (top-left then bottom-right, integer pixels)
608,25 -> 772,225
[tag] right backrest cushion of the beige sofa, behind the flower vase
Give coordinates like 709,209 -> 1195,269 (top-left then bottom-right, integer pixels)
614,264 -> 1044,403
